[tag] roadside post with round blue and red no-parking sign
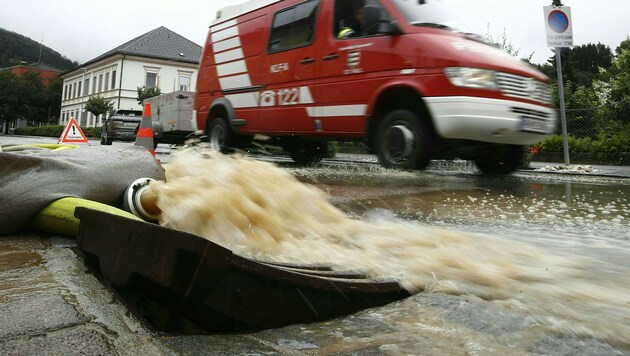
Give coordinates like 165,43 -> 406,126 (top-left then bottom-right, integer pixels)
543,6 -> 573,166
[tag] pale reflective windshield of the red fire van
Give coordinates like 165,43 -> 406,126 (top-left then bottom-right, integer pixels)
392,0 -> 470,33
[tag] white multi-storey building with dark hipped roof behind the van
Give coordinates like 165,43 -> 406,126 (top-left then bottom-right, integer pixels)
59,26 -> 202,127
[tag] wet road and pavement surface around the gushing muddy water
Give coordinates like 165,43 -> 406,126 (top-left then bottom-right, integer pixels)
0,137 -> 630,355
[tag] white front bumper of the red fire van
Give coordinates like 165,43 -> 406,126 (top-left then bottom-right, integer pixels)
425,96 -> 557,145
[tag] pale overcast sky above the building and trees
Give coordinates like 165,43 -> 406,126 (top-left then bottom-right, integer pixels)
0,0 -> 630,63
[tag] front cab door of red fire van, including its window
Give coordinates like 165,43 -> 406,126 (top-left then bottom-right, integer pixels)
310,0 -> 402,137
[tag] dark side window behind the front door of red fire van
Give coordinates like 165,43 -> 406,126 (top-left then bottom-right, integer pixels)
267,0 -> 319,53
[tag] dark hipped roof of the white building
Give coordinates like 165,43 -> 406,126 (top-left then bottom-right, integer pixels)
80,26 -> 202,67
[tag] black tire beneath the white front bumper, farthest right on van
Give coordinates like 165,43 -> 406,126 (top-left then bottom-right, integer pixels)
475,144 -> 525,174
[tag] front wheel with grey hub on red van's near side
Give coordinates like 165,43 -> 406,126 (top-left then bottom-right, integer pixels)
374,110 -> 433,170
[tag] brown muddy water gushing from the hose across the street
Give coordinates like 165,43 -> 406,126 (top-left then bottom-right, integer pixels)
150,150 -> 630,350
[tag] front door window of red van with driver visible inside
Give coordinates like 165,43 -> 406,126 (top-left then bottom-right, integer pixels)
333,0 -> 393,39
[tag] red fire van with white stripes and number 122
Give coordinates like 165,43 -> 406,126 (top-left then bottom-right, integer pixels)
195,0 -> 556,173
